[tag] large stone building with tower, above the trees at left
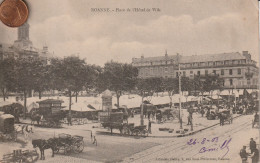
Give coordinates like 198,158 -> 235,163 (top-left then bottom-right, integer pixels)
0,23 -> 52,60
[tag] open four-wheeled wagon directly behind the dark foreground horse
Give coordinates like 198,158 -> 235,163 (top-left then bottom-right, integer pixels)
54,133 -> 84,155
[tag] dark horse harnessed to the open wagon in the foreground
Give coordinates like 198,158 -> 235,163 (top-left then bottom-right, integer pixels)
32,138 -> 57,160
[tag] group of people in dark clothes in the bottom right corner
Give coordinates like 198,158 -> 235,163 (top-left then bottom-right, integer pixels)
239,138 -> 259,163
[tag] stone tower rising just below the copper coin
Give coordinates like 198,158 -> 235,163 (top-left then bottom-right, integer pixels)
14,22 -> 32,48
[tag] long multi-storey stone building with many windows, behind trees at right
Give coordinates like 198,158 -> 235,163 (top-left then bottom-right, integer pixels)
132,51 -> 259,89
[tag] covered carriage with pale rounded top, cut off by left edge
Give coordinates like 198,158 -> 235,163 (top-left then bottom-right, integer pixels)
0,113 -> 17,141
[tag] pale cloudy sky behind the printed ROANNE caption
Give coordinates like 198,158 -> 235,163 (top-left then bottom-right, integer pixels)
0,0 -> 259,65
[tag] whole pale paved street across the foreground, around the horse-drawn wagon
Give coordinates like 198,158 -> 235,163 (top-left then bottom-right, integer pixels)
1,112 -> 258,162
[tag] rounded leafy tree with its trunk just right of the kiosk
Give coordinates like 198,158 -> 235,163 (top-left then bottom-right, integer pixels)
99,61 -> 138,107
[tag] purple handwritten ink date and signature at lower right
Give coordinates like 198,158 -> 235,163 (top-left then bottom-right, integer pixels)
187,137 -> 232,158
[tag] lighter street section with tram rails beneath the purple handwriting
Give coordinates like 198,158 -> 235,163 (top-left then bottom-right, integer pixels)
124,115 -> 259,163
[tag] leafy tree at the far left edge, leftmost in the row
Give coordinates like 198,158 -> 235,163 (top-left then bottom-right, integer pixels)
0,58 -> 15,101
